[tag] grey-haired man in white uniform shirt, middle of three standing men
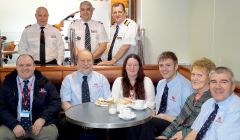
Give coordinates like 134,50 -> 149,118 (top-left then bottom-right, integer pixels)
68,1 -> 108,64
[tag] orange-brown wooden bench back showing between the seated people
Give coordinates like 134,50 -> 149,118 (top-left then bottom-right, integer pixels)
0,65 -> 240,95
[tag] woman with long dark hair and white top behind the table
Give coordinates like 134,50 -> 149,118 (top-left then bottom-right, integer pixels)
112,54 -> 155,109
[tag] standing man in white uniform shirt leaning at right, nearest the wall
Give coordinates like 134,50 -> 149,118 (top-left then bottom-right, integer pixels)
99,3 -> 138,66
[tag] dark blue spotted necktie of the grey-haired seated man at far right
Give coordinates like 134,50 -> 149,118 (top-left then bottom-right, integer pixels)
196,104 -> 219,140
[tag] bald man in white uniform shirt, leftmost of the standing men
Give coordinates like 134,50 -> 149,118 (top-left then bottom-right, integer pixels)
18,7 -> 64,65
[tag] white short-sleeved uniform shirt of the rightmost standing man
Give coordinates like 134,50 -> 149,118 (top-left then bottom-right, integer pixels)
103,18 -> 138,65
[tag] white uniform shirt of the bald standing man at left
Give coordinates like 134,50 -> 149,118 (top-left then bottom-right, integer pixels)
18,24 -> 64,65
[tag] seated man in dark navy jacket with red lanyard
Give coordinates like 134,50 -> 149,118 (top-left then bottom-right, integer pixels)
0,54 -> 61,140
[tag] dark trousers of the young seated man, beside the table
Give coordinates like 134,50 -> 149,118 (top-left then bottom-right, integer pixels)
127,117 -> 171,140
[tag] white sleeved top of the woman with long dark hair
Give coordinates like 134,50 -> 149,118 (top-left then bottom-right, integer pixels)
112,76 -> 155,109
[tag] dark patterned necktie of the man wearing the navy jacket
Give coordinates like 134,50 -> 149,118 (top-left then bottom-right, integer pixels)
20,80 -> 31,129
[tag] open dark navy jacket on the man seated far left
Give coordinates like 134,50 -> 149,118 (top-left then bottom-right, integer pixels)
0,70 -> 61,129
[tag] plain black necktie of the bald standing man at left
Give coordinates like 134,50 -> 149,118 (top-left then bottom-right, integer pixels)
40,27 -> 46,64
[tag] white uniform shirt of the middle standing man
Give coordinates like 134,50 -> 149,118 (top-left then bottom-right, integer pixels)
68,19 -> 109,52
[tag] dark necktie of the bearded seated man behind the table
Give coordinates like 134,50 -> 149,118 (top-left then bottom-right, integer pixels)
82,76 -> 90,103
